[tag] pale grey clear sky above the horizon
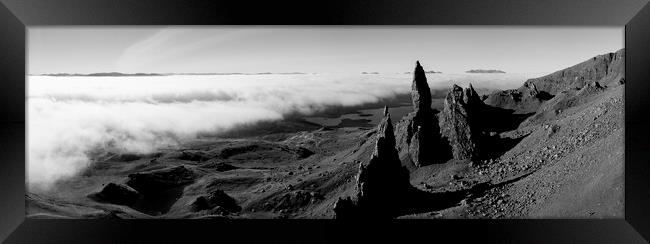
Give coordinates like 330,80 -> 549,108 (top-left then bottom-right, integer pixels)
27,26 -> 624,74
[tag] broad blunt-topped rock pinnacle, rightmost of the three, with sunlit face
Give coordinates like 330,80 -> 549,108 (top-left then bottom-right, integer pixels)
438,84 -> 482,159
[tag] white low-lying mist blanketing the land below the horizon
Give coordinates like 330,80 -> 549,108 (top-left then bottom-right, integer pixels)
27,74 -> 539,190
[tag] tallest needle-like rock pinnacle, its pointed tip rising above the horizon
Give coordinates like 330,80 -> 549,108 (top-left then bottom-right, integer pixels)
397,61 -> 446,167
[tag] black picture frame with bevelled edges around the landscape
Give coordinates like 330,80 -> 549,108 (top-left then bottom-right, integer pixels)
0,0 -> 650,243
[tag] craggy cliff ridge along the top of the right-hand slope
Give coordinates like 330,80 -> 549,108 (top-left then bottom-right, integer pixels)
485,49 -> 625,113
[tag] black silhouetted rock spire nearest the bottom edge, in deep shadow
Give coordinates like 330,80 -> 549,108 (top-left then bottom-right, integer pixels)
334,108 -> 412,218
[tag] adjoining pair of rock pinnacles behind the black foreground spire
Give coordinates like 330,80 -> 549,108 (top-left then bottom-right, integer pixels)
396,62 -> 484,167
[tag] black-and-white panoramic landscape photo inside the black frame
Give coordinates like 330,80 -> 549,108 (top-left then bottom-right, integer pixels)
25,26 -> 625,219
